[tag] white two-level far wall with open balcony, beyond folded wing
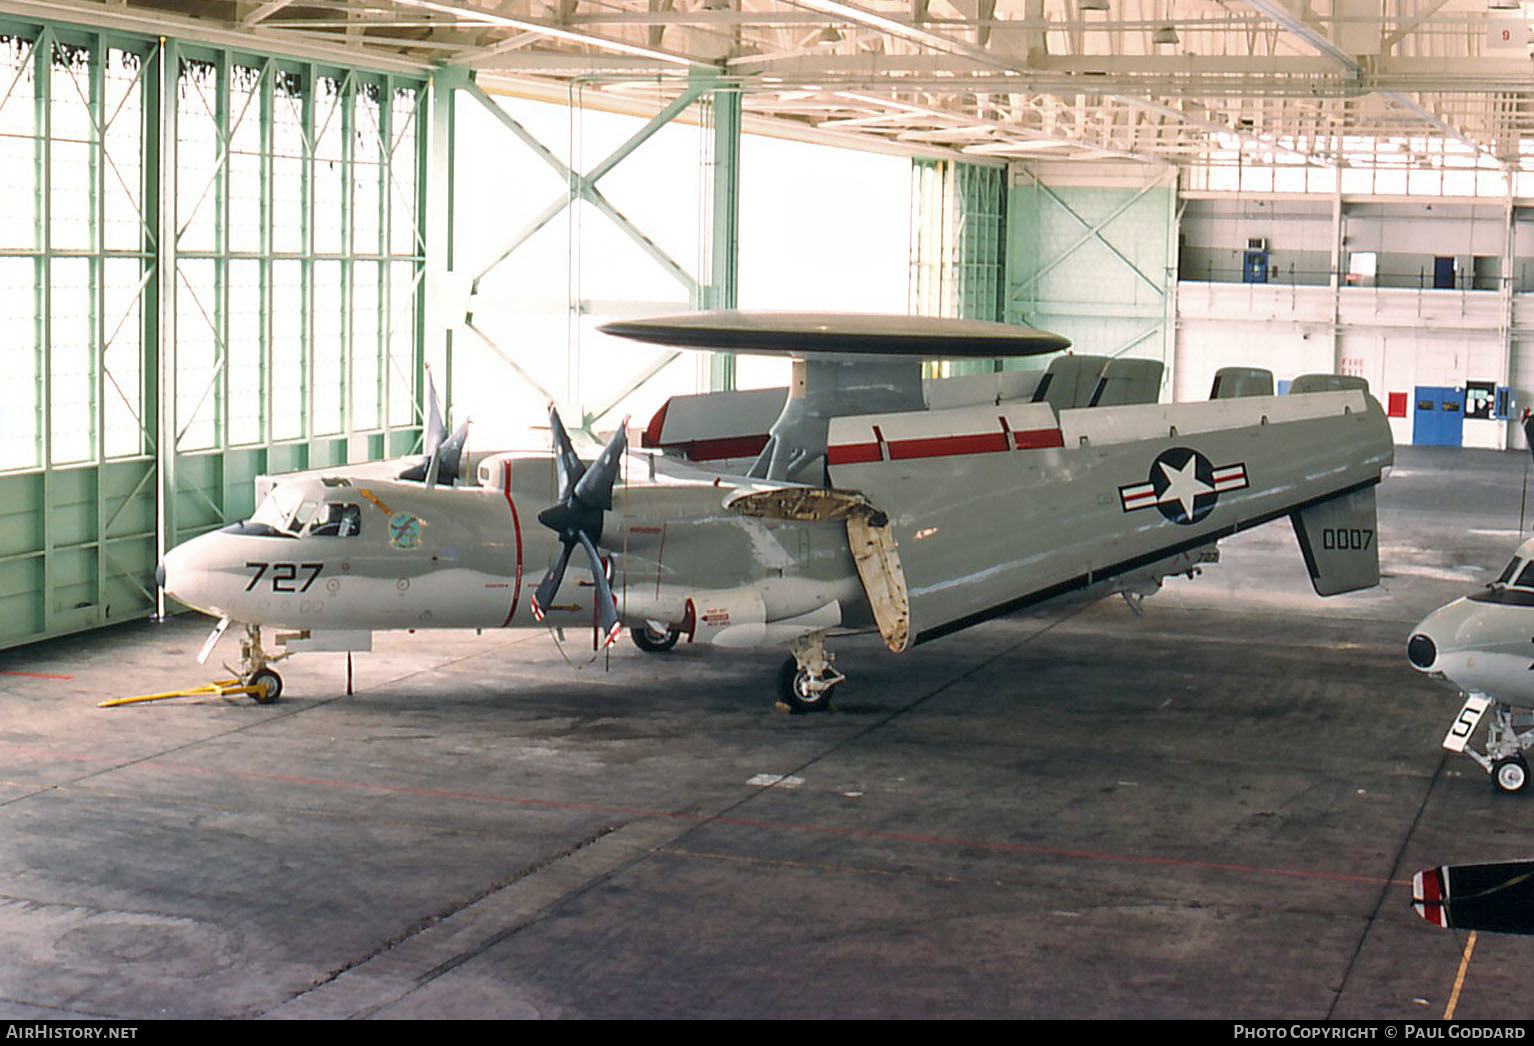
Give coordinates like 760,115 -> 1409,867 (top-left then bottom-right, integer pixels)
1175,193 -> 1534,448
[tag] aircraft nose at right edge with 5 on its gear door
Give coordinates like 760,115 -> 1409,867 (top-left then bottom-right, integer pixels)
1407,419 -> 1534,791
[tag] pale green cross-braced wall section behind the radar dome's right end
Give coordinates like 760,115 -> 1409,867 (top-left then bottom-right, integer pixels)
1006,163 -> 1177,388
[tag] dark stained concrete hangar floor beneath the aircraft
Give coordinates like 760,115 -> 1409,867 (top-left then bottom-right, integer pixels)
0,448 -> 1534,1020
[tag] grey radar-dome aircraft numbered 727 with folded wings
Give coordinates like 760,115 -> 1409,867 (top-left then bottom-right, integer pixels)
160,311 -> 1393,712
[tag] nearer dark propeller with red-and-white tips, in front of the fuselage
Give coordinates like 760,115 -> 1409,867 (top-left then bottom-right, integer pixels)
532,406 -> 629,646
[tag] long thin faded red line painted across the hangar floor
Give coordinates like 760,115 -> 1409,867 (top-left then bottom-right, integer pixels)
0,745 -> 1411,886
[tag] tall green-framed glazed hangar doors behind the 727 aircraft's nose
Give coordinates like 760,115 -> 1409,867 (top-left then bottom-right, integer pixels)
0,10 -> 425,647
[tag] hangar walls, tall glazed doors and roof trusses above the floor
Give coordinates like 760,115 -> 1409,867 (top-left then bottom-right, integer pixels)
9,0 -> 1534,646
